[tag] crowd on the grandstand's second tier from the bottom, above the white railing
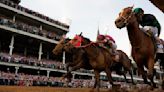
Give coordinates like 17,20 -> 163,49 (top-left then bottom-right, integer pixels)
0,52 -> 93,73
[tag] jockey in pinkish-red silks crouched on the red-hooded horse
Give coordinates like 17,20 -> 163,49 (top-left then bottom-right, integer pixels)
96,35 -> 119,62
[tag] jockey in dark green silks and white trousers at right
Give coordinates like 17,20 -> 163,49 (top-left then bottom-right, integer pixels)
133,8 -> 163,52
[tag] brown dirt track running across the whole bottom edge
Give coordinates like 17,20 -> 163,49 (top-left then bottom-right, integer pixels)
0,86 -> 164,92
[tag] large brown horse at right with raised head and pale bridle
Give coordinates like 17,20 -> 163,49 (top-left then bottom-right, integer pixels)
115,7 -> 156,87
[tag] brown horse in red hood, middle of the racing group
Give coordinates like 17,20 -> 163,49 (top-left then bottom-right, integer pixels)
65,37 -> 115,92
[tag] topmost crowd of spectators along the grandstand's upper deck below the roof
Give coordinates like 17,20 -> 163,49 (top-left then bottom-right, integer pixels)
0,0 -> 69,28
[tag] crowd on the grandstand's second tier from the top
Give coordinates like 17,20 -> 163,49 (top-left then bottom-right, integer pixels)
0,17 -> 61,40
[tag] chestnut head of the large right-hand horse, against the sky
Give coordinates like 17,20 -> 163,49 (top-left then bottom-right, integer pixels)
115,6 -> 135,28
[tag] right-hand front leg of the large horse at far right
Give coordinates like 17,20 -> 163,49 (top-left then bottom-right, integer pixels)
148,58 -> 156,87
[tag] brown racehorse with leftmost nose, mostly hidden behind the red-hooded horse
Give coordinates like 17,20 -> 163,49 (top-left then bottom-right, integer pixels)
53,35 -> 134,84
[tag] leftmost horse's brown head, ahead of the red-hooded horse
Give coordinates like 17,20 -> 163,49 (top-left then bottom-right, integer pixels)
52,38 -> 70,55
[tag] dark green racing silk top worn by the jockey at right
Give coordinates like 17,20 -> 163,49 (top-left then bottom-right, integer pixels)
139,14 -> 161,36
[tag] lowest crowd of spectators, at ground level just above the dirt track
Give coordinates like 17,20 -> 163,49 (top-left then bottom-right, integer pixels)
0,71 -> 107,88
